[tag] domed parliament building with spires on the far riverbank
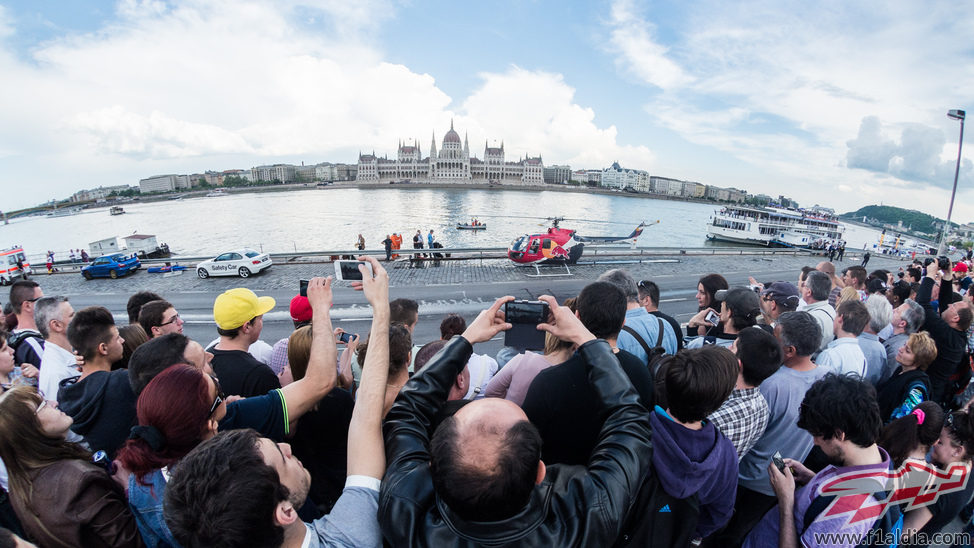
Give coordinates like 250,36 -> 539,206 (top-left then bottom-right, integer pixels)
356,121 -> 544,185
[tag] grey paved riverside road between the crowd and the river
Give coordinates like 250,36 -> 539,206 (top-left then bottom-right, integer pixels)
26,256 -> 906,354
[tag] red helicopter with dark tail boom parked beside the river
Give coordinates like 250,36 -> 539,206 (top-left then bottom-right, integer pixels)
507,217 -> 659,265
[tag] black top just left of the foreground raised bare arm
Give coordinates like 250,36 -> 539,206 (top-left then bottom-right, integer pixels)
290,388 -> 355,514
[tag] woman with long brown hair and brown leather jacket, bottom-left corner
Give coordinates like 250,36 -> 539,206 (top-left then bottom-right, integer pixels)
0,387 -> 143,547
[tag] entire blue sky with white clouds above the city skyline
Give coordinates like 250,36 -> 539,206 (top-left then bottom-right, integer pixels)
0,0 -> 974,222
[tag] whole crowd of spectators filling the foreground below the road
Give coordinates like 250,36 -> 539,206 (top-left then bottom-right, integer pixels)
0,255 -> 974,547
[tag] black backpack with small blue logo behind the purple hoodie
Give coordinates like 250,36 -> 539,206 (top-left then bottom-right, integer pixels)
613,460 -> 700,548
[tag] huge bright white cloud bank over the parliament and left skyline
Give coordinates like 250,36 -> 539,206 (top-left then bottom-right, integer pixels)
0,0 -> 652,207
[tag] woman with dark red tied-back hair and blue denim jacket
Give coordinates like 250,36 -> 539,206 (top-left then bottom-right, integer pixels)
118,364 -> 226,547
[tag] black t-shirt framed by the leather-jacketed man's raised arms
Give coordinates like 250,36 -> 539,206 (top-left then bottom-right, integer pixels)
521,350 -> 654,465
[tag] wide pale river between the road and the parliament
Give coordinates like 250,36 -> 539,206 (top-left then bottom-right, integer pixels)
0,187 -> 879,260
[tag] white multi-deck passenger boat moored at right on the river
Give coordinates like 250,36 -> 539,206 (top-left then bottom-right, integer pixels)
707,206 -> 845,247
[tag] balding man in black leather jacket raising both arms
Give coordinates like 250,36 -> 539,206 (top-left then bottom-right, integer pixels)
379,296 -> 652,548
